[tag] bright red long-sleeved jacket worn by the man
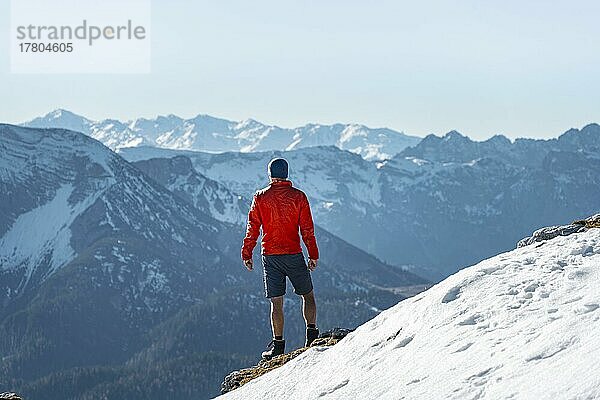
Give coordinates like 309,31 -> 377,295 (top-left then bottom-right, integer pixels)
242,181 -> 319,260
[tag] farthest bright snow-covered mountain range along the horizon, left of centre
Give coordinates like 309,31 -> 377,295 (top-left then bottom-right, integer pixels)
24,109 -> 421,160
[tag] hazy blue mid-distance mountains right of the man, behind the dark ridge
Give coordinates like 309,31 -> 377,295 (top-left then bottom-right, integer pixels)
122,124 -> 600,279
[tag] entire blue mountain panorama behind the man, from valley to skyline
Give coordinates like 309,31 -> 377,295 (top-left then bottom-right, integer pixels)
0,110 -> 600,400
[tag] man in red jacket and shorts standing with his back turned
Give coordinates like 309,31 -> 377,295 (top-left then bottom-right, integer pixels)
242,158 -> 319,359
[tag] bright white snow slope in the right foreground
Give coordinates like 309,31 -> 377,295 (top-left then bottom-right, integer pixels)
222,229 -> 600,399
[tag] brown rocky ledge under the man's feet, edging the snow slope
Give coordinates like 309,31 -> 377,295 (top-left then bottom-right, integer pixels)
221,328 -> 352,394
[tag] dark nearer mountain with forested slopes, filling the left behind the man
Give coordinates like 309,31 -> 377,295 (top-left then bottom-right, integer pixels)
0,124 -> 427,400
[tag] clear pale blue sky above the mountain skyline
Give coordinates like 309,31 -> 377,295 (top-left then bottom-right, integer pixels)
0,0 -> 600,139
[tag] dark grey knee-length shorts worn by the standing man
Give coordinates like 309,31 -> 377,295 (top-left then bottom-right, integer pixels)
262,253 -> 313,297
